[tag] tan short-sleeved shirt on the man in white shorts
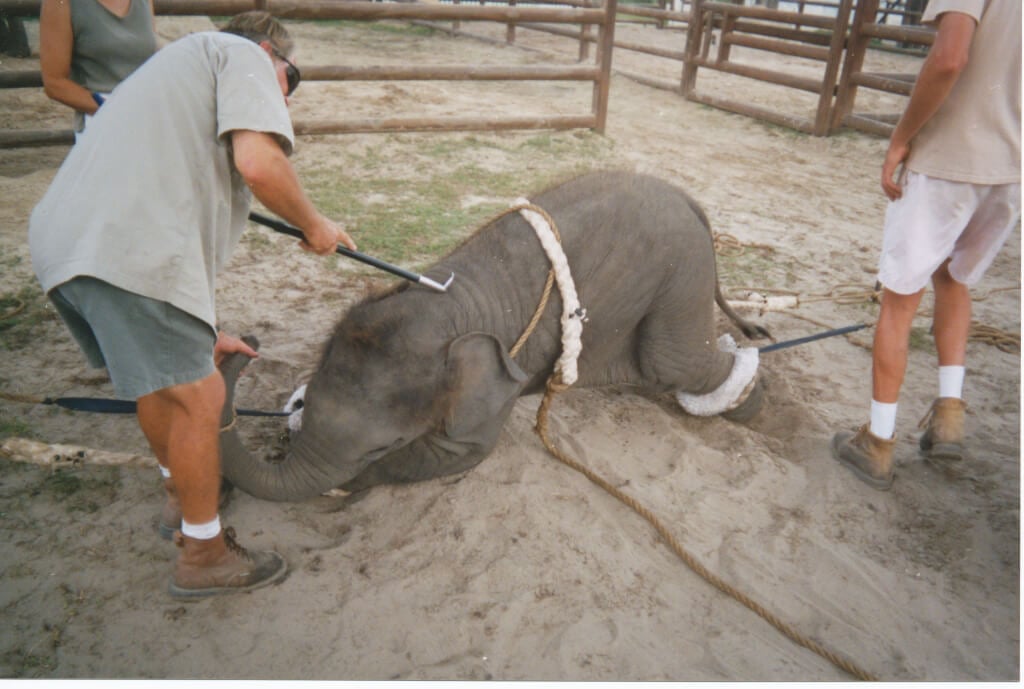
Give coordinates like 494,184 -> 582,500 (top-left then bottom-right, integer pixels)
906,0 -> 1021,184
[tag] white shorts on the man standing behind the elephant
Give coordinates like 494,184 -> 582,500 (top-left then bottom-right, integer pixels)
879,171 -> 1021,294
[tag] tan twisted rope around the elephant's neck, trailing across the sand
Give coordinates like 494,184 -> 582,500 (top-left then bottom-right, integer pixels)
507,204 -> 878,682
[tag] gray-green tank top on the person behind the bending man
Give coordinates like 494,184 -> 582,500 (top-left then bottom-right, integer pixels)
71,0 -> 157,93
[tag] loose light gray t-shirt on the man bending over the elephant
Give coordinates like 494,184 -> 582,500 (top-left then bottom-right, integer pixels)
29,32 -> 294,326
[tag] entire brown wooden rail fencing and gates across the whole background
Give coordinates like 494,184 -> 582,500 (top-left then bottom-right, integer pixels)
0,0 -> 934,147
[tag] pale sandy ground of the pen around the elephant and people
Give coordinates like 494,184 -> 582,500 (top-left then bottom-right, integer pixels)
0,13 -> 1021,681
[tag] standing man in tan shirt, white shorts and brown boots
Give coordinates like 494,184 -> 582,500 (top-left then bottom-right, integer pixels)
831,0 -> 1021,490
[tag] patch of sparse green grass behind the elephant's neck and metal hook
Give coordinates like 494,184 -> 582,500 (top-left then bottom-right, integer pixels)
302,132 -> 611,268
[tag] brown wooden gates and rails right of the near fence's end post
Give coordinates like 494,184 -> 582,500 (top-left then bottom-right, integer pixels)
423,0 -> 934,136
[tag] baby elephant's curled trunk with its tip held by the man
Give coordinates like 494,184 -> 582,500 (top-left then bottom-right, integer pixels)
220,336 -> 352,502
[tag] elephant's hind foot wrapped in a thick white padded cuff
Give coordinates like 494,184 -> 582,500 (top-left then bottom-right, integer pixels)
676,335 -> 764,423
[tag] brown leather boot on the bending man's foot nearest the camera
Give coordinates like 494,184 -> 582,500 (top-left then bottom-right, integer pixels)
170,527 -> 288,599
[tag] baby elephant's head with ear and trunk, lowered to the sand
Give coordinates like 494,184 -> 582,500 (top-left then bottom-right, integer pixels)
221,298 -> 527,501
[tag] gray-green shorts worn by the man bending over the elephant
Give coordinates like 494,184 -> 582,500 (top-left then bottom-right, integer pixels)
49,276 -> 217,399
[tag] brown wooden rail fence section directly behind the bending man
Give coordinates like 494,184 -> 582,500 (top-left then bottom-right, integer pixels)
0,0 -> 615,148
